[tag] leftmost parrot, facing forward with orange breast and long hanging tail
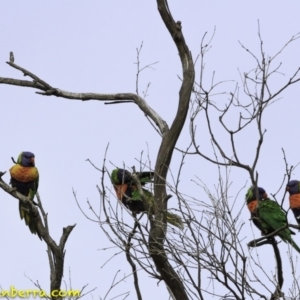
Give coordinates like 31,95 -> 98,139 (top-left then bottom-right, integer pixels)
9,151 -> 42,240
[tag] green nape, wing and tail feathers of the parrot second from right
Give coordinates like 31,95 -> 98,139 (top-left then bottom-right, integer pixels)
246,187 -> 300,253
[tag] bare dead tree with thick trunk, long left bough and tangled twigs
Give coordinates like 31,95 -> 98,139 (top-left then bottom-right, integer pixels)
0,0 -> 300,300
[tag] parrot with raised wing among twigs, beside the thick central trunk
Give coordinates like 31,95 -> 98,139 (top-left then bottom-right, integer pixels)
111,168 -> 183,229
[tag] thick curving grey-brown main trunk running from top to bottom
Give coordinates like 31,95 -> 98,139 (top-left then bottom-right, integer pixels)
149,0 -> 195,300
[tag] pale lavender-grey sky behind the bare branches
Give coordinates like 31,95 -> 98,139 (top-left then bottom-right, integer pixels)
0,0 -> 300,299
